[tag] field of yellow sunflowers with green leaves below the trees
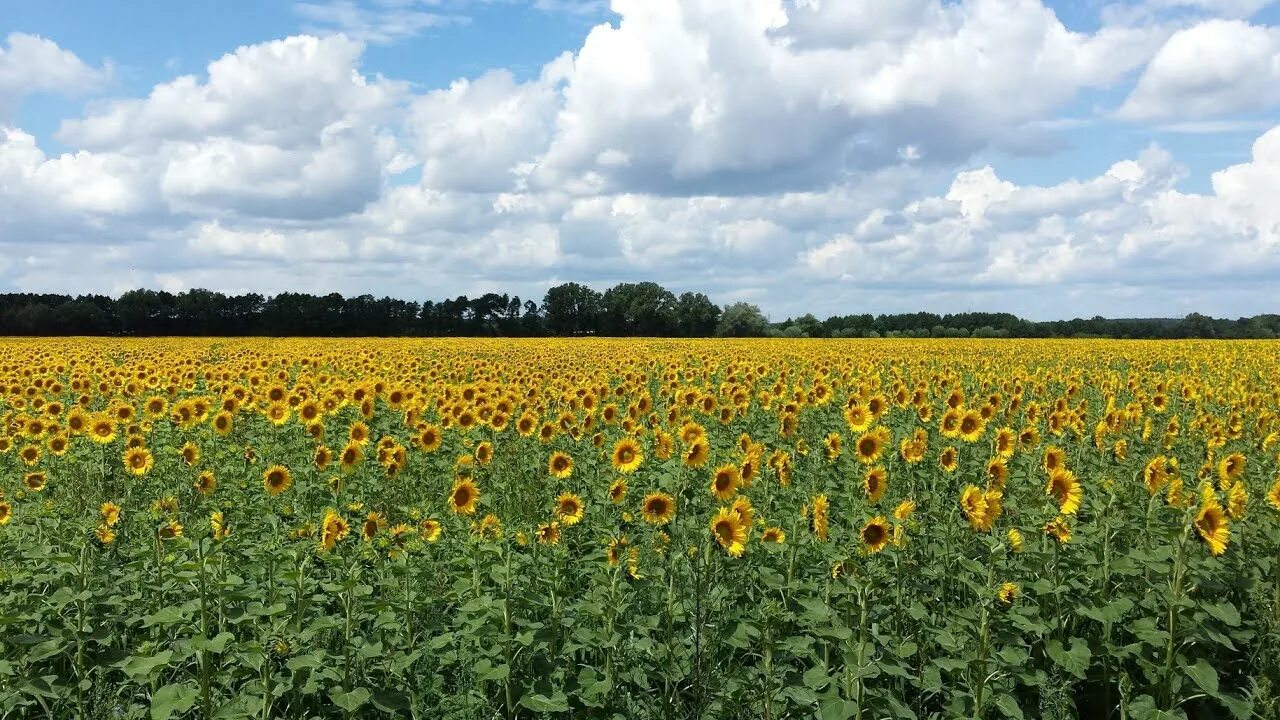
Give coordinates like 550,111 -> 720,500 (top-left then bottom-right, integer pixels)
0,340 -> 1280,720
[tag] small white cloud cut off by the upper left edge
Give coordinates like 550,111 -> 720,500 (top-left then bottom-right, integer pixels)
0,32 -> 111,122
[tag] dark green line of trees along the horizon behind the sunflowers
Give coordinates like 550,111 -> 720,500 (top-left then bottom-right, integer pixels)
0,282 -> 1280,338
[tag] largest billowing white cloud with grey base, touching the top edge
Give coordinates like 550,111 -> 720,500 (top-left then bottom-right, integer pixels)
535,0 -> 1162,193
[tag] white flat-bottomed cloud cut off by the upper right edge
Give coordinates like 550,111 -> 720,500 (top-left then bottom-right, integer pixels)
1119,20 -> 1280,119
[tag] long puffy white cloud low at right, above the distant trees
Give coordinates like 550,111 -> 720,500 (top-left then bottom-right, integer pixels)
803,127 -> 1280,313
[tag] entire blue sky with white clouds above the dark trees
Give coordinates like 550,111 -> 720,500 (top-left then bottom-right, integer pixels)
0,0 -> 1280,318
